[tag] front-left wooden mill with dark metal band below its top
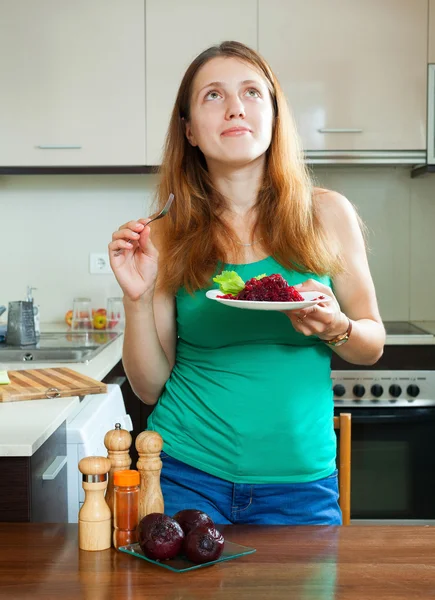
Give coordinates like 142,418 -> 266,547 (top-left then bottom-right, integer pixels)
79,456 -> 112,550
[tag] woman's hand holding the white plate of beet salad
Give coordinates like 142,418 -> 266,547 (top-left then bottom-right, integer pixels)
283,279 -> 349,340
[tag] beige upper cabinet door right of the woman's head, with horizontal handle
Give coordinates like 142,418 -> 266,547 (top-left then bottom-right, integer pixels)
259,0 -> 428,151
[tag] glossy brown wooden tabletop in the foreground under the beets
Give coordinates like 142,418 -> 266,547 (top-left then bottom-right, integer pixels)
0,523 -> 435,600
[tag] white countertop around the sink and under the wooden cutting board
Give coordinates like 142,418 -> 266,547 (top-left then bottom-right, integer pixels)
0,324 -> 123,457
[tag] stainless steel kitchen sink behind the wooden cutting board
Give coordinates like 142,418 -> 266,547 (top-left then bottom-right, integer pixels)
0,332 -> 120,363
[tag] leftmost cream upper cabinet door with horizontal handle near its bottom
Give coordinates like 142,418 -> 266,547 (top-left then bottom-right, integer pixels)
0,0 -> 146,166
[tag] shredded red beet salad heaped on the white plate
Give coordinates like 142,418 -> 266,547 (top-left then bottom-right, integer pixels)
218,273 -> 303,302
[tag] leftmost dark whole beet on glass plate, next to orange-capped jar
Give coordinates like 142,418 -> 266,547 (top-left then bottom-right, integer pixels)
138,513 -> 184,560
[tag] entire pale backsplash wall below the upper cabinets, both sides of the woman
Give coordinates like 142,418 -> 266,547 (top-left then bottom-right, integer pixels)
0,166 -> 435,322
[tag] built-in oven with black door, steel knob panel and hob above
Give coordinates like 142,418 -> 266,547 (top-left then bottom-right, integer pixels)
332,323 -> 435,523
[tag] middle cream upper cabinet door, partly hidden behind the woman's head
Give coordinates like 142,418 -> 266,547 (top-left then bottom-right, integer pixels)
146,0 -> 257,165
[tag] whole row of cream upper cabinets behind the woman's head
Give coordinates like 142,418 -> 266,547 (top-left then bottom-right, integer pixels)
0,0 -> 435,170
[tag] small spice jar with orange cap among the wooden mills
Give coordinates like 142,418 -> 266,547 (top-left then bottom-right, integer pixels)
113,470 -> 140,549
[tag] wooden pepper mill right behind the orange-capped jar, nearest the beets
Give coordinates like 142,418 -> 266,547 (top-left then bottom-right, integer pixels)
136,431 -> 164,521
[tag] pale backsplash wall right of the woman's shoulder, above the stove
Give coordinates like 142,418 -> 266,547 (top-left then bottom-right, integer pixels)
314,167 -> 435,321
